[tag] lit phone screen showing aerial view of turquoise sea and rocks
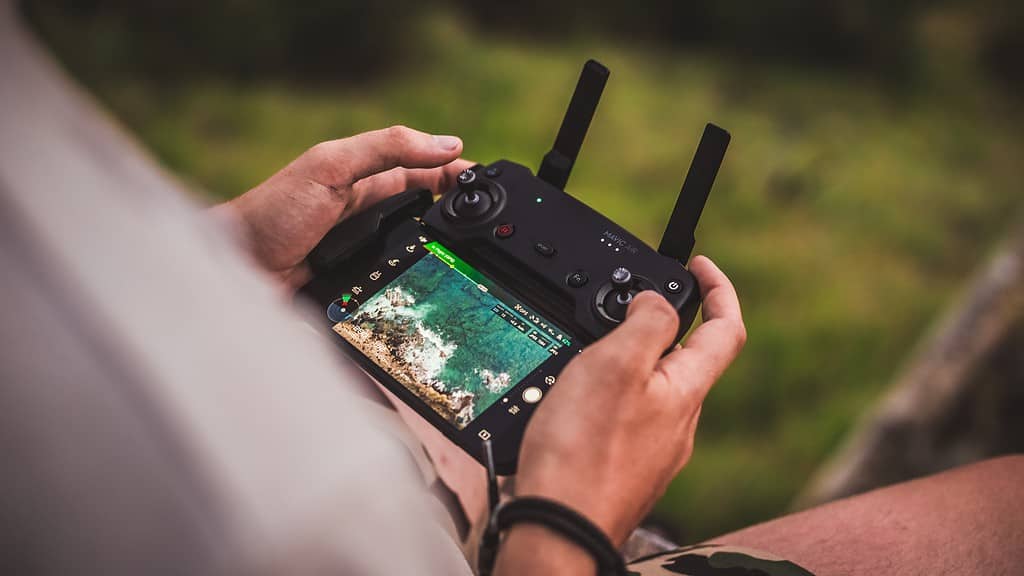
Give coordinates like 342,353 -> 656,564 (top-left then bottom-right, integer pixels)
328,242 -> 572,429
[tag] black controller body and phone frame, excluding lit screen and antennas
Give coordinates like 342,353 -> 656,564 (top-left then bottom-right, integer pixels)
303,160 -> 700,475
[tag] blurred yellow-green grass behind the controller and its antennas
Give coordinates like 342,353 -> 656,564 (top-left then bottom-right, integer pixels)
34,10 -> 1024,540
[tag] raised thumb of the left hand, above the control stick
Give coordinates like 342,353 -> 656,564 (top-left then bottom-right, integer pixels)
309,126 -> 462,186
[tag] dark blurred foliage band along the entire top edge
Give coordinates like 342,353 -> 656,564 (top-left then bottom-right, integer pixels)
23,0 -> 1024,83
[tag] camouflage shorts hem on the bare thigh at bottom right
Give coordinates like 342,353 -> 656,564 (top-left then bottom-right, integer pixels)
627,544 -> 814,576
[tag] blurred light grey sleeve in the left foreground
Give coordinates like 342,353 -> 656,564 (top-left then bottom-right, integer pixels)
0,2 -> 470,575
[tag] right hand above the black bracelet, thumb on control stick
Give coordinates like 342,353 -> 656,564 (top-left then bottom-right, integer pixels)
515,256 -> 746,545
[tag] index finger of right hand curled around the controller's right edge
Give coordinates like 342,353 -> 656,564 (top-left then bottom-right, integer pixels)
658,256 -> 746,396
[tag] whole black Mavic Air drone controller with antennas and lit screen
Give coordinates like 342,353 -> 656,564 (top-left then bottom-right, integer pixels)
302,60 -> 729,474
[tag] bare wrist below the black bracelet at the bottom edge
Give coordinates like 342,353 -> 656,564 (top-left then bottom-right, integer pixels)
495,524 -> 597,576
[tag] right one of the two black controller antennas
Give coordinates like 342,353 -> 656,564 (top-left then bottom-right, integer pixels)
657,123 -> 731,263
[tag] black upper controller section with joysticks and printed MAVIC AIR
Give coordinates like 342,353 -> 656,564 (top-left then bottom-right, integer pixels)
423,160 -> 700,343
